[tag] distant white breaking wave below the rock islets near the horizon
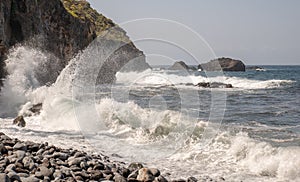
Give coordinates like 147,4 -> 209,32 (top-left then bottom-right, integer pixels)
117,70 -> 294,89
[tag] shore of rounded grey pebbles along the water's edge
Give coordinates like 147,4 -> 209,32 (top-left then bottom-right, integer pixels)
0,132 -> 225,182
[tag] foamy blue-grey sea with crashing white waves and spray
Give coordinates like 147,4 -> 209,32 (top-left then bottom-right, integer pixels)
0,46 -> 300,182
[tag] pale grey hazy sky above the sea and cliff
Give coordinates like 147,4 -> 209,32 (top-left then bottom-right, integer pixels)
89,0 -> 300,65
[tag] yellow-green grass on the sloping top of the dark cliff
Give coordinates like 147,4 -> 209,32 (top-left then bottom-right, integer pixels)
61,0 -> 129,42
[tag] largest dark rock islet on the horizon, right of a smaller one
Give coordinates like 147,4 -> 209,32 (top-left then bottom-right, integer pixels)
198,57 -> 246,71
